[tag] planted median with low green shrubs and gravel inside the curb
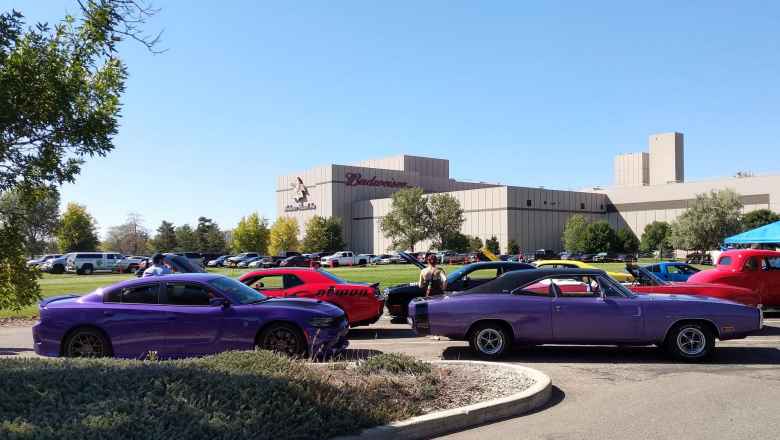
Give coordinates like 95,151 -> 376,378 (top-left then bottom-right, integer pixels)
0,351 -> 548,439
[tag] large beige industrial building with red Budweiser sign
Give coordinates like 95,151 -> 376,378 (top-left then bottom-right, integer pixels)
276,133 -> 780,253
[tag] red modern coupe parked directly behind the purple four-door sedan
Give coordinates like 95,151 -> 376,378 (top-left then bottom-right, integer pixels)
239,267 -> 385,327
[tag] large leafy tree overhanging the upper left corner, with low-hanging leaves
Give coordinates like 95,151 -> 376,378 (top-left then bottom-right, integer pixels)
0,0 -> 156,308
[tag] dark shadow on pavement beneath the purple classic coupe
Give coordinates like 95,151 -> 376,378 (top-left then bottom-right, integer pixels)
442,345 -> 780,365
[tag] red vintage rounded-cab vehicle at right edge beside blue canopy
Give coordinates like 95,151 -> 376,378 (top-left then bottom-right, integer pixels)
688,249 -> 780,309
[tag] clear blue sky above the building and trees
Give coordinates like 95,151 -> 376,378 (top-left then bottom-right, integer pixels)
10,0 -> 780,237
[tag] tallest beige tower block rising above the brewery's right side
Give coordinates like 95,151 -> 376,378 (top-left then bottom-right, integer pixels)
648,133 -> 685,185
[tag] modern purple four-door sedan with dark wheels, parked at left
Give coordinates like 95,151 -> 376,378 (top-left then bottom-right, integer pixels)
33,273 -> 348,358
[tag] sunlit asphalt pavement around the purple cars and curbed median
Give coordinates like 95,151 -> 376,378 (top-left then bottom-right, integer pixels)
0,314 -> 780,440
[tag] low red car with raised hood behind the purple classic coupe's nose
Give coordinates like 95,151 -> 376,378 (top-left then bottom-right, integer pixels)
626,265 -> 761,306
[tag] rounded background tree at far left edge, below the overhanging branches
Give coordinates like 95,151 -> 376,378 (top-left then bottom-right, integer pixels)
0,187 -> 60,255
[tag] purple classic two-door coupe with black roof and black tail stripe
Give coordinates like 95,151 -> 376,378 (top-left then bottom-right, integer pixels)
409,269 -> 763,361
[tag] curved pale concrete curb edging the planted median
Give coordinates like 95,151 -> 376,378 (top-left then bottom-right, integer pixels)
336,361 -> 552,440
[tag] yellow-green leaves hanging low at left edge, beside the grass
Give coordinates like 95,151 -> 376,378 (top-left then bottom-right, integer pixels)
0,214 -> 41,310
